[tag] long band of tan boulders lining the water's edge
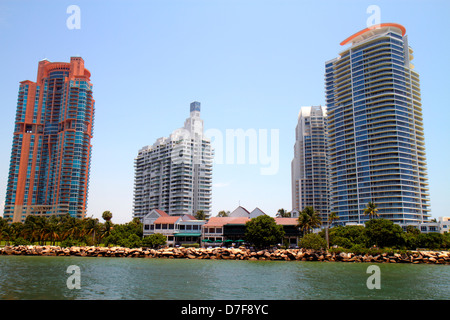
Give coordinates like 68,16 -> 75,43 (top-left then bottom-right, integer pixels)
0,246 -> 450,264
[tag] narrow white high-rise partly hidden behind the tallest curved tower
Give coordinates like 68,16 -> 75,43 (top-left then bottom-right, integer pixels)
291,106 -> 328,221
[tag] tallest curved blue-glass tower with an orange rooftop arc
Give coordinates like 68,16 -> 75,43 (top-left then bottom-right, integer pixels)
325,23 -> 430,223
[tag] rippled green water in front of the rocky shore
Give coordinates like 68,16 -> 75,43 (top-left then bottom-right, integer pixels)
0,256 -> 450,300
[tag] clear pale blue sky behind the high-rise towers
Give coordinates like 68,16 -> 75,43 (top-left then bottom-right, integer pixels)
0,0 -> 450,223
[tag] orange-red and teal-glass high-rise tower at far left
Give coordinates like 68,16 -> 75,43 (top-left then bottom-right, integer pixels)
4,57 -> 94,222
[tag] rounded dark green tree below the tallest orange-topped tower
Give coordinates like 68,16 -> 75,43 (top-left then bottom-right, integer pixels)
366,219 -> 405,248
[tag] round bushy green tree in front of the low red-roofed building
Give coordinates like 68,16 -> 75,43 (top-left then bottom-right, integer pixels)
245,215 -> 285,248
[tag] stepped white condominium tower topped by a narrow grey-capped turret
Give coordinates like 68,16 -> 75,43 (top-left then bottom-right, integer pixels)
133,102 -> 213,218
